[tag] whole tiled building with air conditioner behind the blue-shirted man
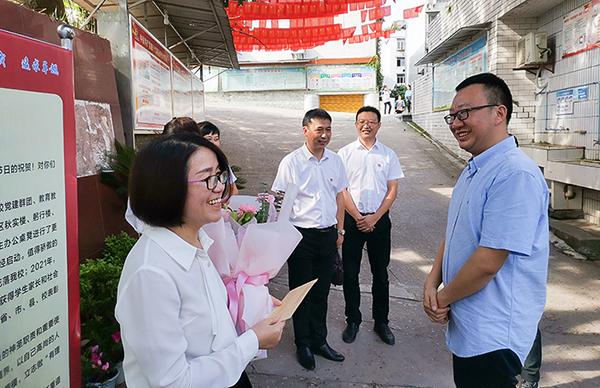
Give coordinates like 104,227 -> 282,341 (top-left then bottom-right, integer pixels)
407,0 -> 600,225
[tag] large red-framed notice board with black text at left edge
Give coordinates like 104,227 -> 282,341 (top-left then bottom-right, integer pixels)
0,30 -> 81,387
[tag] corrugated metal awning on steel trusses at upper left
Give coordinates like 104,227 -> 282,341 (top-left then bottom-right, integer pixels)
76,0 -> 239,68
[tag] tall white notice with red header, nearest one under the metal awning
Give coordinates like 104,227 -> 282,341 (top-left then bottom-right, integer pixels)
130,18 -> 173,129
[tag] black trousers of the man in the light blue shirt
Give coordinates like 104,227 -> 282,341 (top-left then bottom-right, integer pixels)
452,349 -> 521,388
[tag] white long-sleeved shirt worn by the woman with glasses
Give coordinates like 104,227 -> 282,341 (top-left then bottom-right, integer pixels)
115,226 -> 258,388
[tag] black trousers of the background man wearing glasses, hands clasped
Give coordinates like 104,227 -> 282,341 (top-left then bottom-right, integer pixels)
342,212 -> 392,324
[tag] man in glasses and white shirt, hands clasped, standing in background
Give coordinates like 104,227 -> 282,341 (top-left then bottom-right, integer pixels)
338,106 -> 404,345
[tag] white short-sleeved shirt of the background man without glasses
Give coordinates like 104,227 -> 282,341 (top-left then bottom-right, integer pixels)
271,144 -> 348,228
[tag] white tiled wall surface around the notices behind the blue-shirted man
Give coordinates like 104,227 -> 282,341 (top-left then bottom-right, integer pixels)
413,0 -> 600,225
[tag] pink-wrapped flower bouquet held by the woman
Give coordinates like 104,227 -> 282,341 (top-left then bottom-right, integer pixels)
204,186 -> 302,340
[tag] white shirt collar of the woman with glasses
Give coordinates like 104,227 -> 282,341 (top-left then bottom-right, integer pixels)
144,226 -> 213,271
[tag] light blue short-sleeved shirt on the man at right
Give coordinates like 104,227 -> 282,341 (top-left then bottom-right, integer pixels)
442,136 -> 549,363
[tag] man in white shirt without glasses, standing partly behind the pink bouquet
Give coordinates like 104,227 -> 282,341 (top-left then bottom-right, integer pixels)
272,109 -> 347,370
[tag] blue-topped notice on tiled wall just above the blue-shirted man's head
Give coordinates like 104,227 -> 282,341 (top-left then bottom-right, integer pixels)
433,37 -> 488,111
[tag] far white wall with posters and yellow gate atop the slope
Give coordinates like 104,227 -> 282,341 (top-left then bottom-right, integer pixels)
204,36 -> 378,112
